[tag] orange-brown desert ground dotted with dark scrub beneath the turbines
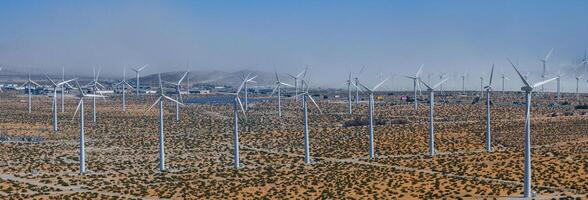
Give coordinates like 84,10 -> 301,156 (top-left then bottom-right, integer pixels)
0,92 -> 588,199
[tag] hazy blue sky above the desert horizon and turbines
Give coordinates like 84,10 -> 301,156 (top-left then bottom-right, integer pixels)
0,0 -> 588,88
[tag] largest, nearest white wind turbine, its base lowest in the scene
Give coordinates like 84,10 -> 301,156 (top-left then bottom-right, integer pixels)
508,59 -> 557,198
